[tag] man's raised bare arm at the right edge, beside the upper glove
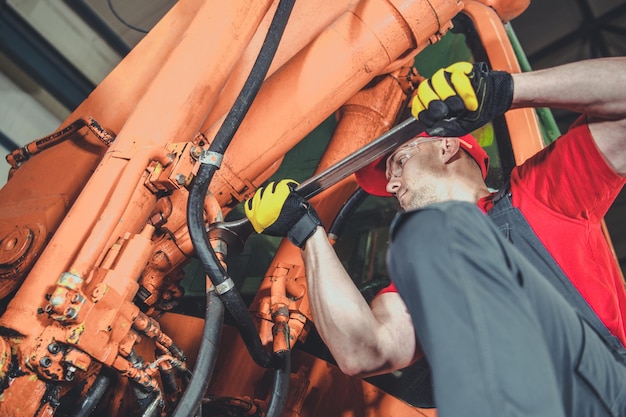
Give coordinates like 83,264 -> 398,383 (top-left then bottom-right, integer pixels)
512,57 -> 626,176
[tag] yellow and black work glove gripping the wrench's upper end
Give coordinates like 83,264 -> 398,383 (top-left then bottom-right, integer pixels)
411,62 -> 513,136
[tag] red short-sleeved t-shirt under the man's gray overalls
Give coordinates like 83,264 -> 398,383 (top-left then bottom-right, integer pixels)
381,118 -> 626,345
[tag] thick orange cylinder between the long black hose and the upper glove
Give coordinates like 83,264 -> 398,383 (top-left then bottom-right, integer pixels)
200,0 -> 462,205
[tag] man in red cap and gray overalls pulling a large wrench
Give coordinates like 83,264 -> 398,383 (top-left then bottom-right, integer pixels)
245,58 -> 626,417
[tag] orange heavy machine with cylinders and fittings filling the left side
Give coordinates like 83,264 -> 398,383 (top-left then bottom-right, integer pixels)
0,0 -> 542,417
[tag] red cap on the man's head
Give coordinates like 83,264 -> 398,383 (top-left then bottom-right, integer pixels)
354,132 -> 489,197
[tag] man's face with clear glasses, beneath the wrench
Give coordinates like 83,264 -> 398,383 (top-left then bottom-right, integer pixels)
386,137 -> 442,210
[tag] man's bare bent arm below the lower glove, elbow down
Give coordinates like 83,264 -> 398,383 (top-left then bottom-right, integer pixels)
303,227 -> 421,377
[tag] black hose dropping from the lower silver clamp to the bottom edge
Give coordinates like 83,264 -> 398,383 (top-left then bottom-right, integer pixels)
172,290 -> 224,417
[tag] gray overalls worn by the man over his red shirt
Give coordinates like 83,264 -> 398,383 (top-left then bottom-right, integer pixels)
388,193 -> 626,417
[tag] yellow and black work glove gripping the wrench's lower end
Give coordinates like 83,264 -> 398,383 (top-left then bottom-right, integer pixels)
244,179 -> 322,248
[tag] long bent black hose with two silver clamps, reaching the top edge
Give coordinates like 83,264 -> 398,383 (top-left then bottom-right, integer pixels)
187,0 -> 294,368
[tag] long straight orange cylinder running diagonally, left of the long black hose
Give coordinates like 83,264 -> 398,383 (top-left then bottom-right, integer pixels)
0,0 -> 269,334
